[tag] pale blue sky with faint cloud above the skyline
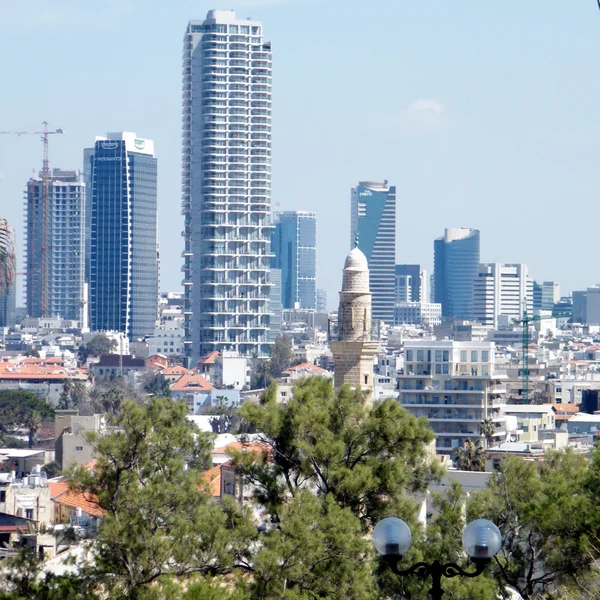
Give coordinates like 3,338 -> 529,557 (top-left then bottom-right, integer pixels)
0,0 -> 600,309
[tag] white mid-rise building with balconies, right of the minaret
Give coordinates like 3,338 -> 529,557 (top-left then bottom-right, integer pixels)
398,341 -> 507,454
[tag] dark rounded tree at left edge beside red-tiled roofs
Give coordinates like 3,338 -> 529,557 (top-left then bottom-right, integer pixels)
0,390 -> 54,448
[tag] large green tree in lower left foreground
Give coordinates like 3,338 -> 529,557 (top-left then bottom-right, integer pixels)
74,398 -> 256,599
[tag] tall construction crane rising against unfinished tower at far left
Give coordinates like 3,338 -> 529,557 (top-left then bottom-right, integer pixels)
0,121 -> 65,317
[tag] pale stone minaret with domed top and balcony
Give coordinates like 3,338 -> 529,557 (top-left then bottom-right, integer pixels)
330,248 -> 379,393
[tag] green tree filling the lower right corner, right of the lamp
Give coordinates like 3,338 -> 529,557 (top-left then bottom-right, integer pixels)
468,450 -> 600,599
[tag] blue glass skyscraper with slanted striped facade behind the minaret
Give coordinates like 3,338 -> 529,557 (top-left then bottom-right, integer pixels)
350,181 -> 396,324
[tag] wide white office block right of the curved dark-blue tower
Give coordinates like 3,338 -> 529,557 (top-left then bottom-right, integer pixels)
473,263 -> 533,329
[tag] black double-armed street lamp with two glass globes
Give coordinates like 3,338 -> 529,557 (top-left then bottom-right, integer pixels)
373,517 -> 502,600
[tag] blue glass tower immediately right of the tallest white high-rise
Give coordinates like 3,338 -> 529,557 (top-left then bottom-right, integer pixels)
271,211 -> 317,310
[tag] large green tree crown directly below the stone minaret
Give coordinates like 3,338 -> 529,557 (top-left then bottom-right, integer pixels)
238,377 -> 436,522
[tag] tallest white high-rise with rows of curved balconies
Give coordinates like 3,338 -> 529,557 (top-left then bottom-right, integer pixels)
182,10 -> 272,362
